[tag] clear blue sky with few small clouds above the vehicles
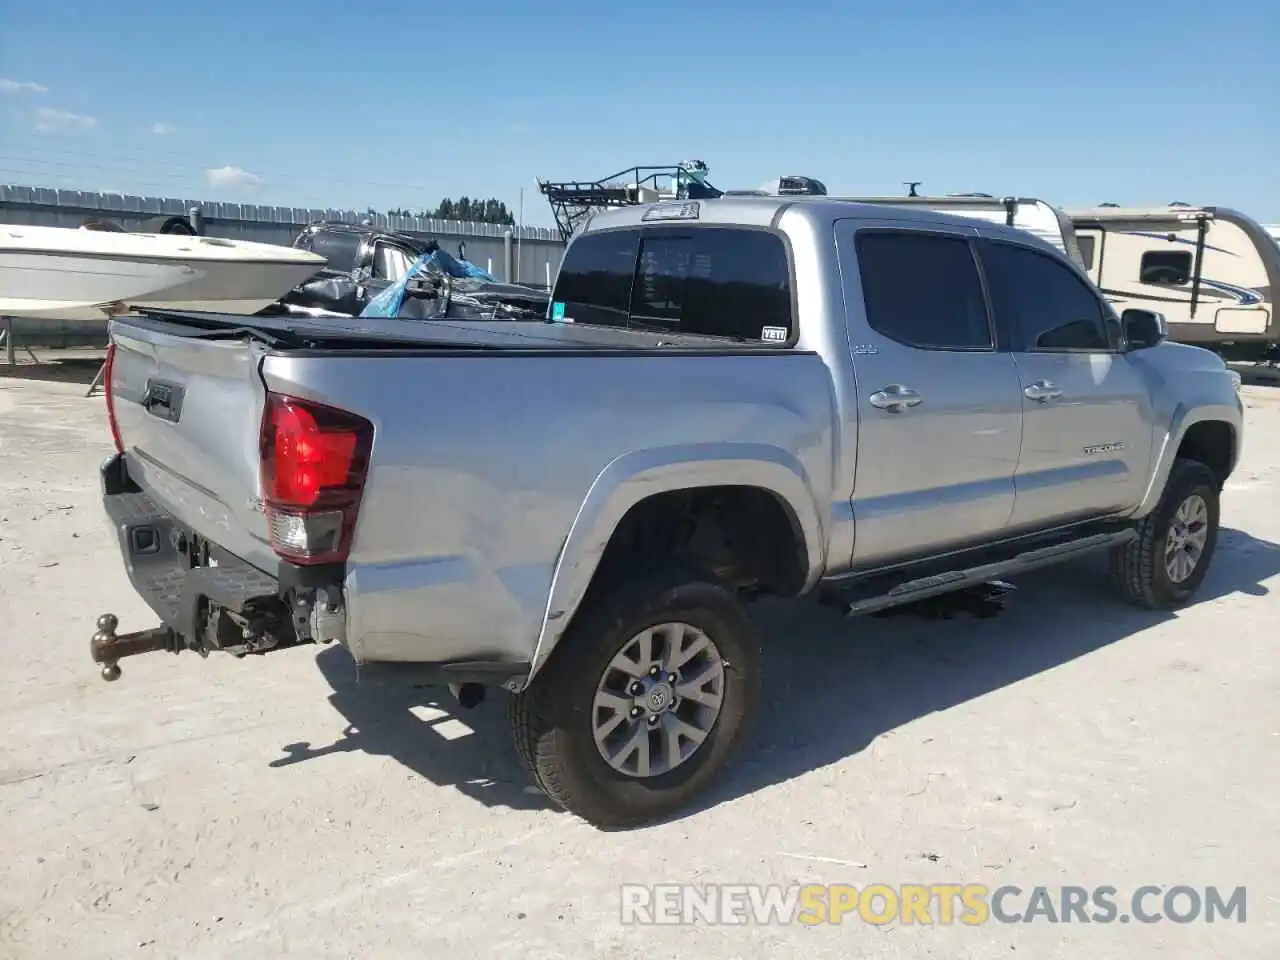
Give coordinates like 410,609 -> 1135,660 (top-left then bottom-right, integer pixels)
0,0 -> 1280,225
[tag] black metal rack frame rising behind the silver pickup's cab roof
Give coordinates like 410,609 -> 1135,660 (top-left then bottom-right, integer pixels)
538,160 -> 723,242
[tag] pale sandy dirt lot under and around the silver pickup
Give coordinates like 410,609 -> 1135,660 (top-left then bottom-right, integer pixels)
0,369 -> 1280,960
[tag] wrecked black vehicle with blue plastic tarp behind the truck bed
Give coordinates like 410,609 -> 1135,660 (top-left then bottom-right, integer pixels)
273,223 -> 549,319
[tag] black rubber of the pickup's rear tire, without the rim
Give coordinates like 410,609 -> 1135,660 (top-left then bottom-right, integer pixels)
511,566 -> 760,828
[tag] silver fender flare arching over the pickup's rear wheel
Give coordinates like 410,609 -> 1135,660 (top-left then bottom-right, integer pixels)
529,443 -> 826,681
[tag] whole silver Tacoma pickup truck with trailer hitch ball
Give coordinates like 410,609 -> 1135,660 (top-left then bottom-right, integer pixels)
91,197 -> 1242,827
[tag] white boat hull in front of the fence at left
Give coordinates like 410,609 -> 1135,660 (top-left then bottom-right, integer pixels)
0,227 -> 324,320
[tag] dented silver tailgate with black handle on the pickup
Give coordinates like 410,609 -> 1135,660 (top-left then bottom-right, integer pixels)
109,319 -> 275,570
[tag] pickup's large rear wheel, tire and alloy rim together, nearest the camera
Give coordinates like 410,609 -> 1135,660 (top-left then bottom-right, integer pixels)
511,567 -> 760,828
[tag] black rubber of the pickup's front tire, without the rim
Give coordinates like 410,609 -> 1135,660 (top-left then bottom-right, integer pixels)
1111,460 -> 1219,609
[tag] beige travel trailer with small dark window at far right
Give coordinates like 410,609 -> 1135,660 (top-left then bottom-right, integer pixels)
1068,204 -> 1280,362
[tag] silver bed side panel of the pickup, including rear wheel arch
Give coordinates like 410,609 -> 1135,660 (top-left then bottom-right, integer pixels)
264,352 -> 833,662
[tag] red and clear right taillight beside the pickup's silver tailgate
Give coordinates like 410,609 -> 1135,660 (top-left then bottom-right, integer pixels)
260,393 -> 374,564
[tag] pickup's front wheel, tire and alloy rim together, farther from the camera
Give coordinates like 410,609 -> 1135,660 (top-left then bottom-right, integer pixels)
1111,460 -> 1219,609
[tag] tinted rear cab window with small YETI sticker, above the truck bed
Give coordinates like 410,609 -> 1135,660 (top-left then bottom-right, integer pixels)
550,227 -> 796,346
